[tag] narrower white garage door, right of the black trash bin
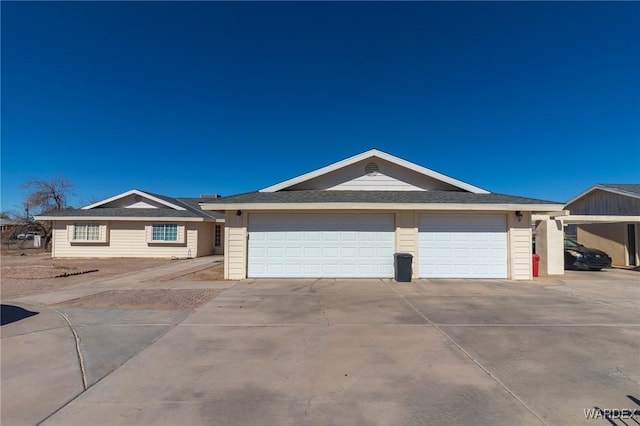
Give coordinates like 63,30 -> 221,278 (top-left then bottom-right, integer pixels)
419,214 -> 507,278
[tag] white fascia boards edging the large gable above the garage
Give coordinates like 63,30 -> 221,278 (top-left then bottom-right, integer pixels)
259,149 -> 489,194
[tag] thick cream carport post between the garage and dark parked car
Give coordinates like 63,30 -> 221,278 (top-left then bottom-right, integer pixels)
536,220 -> 564,276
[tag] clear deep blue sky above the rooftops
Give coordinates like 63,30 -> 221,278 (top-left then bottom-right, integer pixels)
1,2 -> 640,211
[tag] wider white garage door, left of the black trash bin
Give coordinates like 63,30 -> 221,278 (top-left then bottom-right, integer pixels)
247,214 -> 394,278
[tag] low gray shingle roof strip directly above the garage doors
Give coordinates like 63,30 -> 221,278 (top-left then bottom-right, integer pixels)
201,190 -> 563,204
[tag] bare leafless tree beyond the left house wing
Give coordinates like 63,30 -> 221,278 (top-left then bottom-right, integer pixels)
16,176 -> 73,247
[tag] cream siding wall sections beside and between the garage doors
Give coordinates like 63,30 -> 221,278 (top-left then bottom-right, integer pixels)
224,211 -> 532,280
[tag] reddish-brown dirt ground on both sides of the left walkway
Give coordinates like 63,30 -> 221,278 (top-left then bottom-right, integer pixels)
0,245 -> 224,298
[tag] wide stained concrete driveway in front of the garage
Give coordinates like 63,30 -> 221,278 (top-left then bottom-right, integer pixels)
2,270 -> 640,425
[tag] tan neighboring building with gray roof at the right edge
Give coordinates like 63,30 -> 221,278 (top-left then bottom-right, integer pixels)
565,184 -> 640,266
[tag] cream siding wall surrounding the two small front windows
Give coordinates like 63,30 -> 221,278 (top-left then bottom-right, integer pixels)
52,221 -> 208,258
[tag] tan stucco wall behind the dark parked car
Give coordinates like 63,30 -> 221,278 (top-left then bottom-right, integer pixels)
578,223 -> 628,266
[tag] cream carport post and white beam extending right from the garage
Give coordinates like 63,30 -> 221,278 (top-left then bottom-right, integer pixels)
531,215 -> 640,275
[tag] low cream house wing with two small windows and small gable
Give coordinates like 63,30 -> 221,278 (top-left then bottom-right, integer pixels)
36,189 -> 224,258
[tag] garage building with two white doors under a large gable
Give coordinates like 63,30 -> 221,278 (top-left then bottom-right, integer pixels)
201,149 -> 563,280
